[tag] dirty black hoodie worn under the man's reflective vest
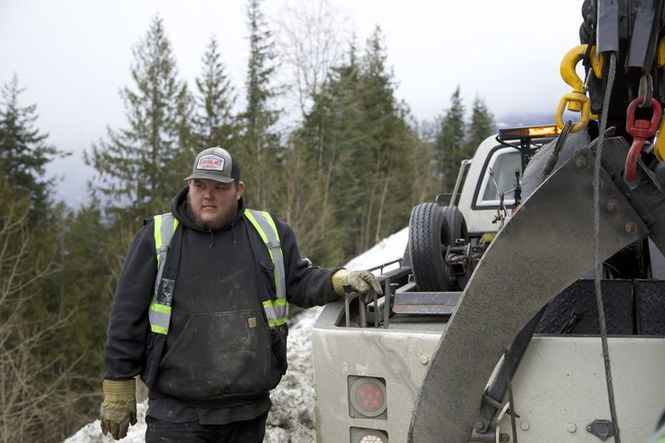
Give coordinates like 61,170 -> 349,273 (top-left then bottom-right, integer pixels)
104,187 -> 338,424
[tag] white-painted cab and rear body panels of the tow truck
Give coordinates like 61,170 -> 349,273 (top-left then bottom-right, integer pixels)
312,130 -> 665,443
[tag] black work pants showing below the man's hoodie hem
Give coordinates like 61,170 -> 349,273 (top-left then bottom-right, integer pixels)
145,412 -> 268,443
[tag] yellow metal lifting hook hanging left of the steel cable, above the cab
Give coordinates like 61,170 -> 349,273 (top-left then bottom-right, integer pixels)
554,45 -> 603,132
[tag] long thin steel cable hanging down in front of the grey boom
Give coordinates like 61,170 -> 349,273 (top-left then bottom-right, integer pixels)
593,52 -> 621,443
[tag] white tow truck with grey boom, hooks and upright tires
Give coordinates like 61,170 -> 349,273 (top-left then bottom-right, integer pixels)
312,0 -> 665,443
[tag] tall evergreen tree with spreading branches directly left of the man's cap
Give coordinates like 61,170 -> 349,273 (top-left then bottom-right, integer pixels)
86,17 -> 191,224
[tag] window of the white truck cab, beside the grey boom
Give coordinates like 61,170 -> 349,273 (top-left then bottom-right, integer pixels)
476,148 -> 522,207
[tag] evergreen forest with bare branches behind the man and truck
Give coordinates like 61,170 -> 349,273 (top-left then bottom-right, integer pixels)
0,0 -> 495,442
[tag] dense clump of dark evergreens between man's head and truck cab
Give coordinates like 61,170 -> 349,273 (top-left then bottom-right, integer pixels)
303,28 -> 432,264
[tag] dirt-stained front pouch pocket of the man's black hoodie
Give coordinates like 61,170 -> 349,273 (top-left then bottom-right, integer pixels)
157,309 -> 281,400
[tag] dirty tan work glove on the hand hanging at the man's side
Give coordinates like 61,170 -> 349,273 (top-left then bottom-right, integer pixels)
99,378 -> 136,440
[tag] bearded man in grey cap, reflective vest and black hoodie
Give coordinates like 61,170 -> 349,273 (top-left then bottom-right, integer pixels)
100,147 -> 381,443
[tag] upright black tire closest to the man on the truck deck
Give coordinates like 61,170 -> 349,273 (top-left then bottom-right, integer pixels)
409,203 -> 455,291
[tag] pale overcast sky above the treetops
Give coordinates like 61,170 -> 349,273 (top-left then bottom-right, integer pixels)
0,0 -> 582,203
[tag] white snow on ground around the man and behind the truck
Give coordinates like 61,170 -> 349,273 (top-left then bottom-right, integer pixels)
64,228 -> 408,443
